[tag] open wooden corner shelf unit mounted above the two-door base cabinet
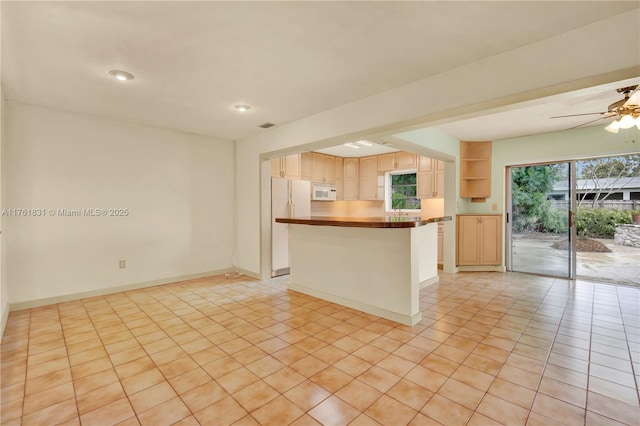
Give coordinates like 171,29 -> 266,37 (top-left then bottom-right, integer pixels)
460,141 -> 491,199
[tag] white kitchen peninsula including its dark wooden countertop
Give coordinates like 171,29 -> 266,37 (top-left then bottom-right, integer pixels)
276,216 -> 451,325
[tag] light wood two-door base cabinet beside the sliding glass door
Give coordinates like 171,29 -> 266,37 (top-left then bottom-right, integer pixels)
456,215 -> 502,266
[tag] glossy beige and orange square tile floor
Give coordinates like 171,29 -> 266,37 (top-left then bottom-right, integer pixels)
1,273 -> 640,426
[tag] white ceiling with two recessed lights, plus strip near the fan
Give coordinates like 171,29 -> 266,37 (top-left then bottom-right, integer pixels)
1,1 -> 639,140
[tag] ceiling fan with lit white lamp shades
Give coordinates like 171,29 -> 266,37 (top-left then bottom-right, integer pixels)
551,85 -> 640,133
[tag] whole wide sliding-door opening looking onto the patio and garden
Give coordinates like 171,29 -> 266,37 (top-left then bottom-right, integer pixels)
507,154 -> 640,285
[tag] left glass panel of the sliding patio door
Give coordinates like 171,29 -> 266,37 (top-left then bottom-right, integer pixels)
507,162 -> 576,279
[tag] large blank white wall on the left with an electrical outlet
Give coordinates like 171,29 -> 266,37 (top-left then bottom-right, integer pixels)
2,102 -> 234,304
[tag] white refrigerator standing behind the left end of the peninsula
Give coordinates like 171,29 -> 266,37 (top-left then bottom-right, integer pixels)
271,178 -> 311,277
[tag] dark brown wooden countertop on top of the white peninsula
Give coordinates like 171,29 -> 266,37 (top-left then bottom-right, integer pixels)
276,216 -> 451,228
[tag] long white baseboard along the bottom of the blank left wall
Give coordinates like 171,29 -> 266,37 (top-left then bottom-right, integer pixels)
9,267 -> 238,312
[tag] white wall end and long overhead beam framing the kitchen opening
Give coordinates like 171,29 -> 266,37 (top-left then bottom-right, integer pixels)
236,12 -> 640,276
